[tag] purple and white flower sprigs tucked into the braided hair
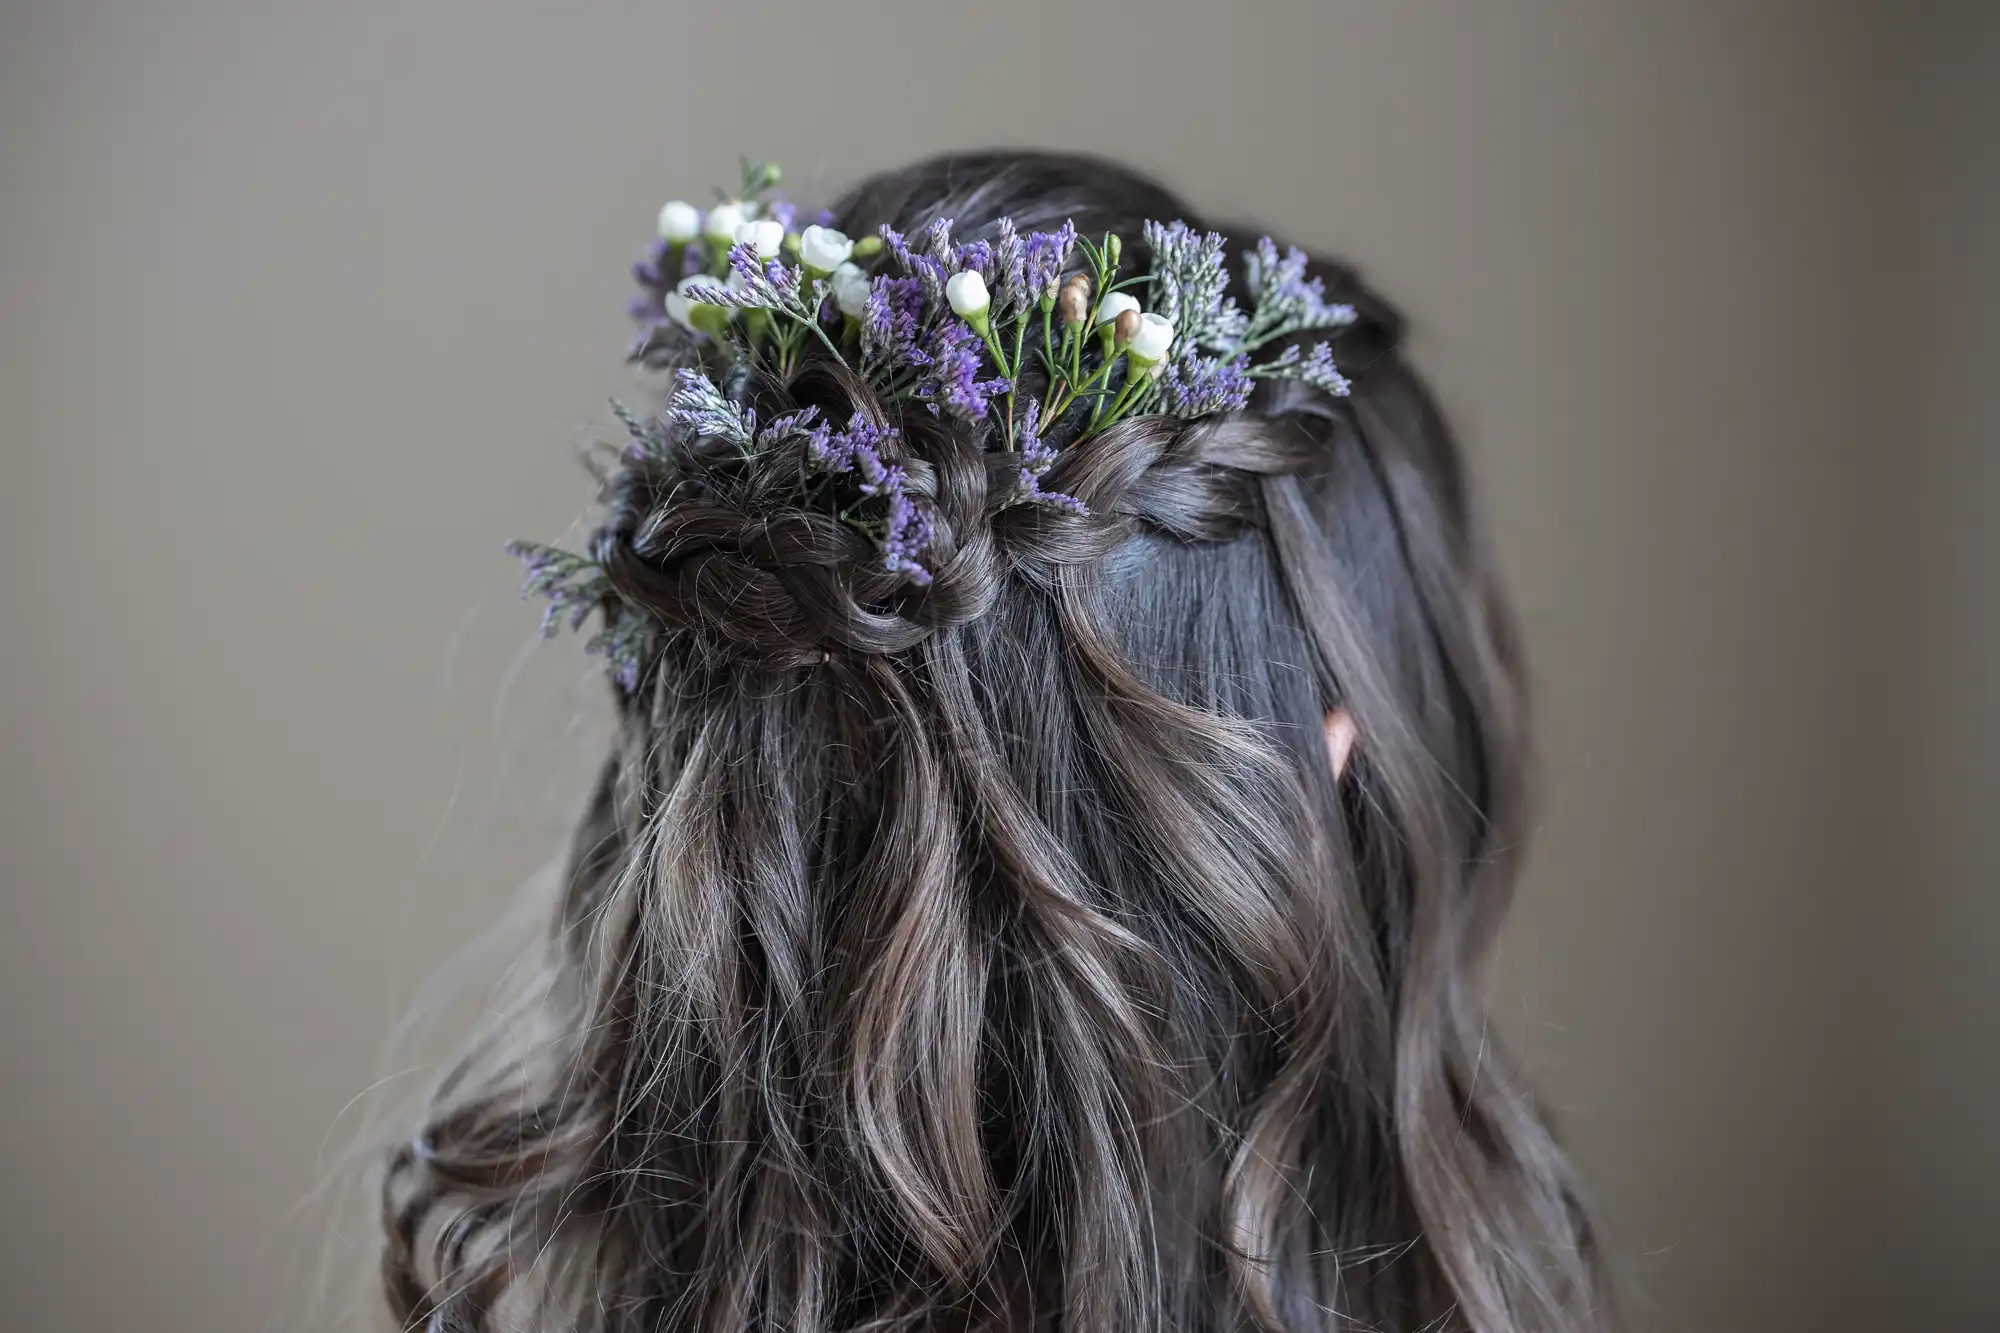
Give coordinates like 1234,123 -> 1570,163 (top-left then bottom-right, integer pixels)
510,160 -> 1354,689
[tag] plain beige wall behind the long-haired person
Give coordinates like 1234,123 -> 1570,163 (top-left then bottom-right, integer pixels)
0,0 -> 2000,1333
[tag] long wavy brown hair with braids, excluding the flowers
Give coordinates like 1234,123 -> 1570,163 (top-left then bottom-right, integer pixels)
386,154 -> 1602,1333
